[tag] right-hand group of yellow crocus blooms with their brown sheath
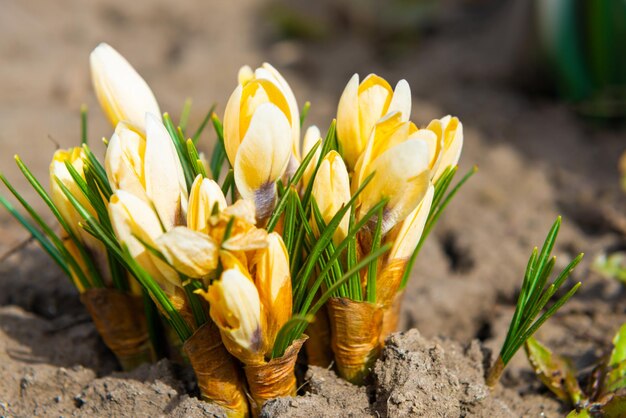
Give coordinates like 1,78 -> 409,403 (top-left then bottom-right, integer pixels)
304,74 -> 463,383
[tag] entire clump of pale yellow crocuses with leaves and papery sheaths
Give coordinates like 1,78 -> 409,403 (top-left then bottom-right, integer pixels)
0,40 -> 463,416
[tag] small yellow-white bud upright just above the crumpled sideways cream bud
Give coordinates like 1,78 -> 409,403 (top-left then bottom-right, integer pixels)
187,175 -> 227,234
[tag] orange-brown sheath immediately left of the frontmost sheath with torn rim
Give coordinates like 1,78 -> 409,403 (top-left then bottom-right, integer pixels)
183,321 -> 249,418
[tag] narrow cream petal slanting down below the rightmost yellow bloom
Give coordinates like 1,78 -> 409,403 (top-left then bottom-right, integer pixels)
389,184 -> 435,261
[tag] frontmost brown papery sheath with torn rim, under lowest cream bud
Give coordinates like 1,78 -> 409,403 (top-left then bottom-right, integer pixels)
244,337 -> 306,417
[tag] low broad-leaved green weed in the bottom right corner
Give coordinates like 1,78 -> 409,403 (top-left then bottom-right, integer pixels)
525,324 -> 626,418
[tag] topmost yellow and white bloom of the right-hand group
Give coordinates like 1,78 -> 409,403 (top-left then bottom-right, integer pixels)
337,74 -> 411,170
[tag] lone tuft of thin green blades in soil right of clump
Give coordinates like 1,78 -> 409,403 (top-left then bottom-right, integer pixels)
487,216 -> 583,387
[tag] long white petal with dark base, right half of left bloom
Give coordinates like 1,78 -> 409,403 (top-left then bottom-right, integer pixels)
144,114 -> 187,230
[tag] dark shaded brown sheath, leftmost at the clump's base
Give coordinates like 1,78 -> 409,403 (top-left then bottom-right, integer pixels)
80,289 -> 156,370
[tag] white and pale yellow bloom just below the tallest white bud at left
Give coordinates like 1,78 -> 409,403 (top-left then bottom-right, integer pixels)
104,114 -> 187,230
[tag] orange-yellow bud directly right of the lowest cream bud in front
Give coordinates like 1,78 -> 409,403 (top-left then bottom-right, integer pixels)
252,232 -> 292,347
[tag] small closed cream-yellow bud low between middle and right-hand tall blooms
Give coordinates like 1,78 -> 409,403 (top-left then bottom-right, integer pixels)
312,151 -> 350,243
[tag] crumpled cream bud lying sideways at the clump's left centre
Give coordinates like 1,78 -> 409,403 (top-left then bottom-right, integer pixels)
156,226 -> 219,278
